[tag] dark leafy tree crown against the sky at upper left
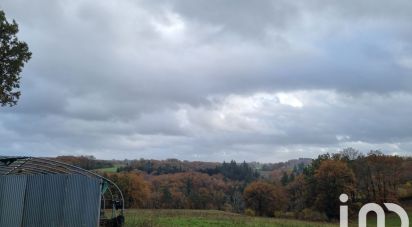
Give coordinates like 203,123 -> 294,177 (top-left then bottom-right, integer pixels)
0,10 -> 31,106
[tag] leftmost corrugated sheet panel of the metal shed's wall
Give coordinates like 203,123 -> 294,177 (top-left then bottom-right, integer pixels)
0,176 -> 27,227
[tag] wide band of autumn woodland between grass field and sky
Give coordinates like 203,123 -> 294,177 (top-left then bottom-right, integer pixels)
63,148 -> 412,221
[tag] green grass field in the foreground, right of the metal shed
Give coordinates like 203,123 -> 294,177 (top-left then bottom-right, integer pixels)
125,209 -> 408,227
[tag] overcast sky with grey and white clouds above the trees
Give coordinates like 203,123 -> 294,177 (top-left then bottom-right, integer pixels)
0,0 -> 412,162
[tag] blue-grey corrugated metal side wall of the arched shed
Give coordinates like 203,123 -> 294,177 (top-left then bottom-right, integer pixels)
0,174 -> 101,227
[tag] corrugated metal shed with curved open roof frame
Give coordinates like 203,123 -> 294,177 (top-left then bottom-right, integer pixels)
0,156 -> 124,227
